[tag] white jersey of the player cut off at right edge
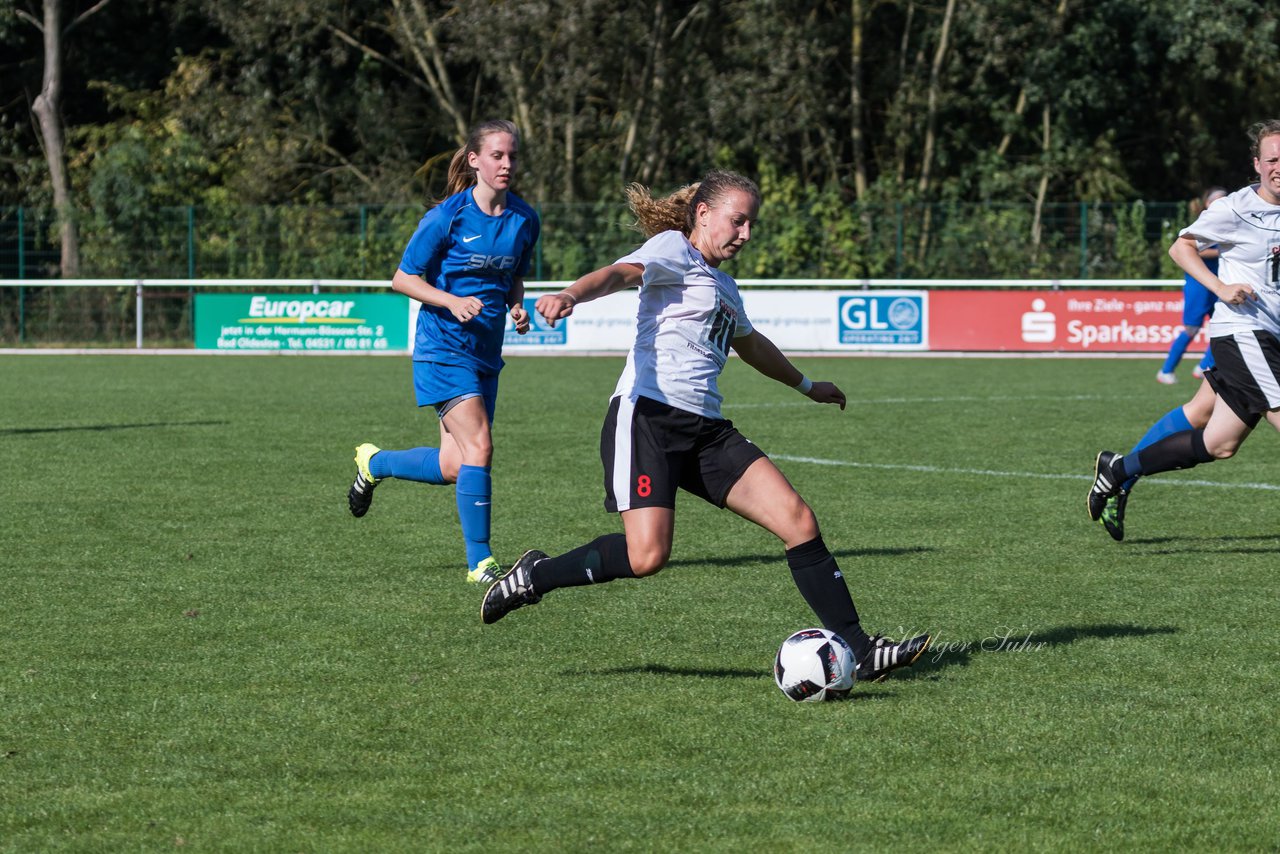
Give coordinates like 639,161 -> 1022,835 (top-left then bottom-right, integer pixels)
1180,184 -> 1280,338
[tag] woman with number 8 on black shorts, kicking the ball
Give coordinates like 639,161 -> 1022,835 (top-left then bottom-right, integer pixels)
481,172 -> 929,681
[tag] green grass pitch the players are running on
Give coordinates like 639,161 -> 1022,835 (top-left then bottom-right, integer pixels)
0,356 -> 1280,851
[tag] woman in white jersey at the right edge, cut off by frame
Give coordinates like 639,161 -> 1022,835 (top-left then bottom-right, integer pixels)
1088,119 -> 1280,522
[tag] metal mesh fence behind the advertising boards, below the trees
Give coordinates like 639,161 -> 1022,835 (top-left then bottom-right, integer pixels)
0,202 -> 1188,346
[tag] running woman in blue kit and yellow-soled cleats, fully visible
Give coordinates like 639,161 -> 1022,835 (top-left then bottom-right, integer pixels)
347,120 -> 540,584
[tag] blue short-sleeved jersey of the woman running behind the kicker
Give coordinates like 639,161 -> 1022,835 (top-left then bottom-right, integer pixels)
399,188 -> 540,374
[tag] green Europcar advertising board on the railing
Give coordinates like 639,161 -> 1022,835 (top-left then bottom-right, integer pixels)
195,293 -> 408,352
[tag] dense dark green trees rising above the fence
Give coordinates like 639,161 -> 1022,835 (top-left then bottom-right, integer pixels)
0,0 -> 1280,275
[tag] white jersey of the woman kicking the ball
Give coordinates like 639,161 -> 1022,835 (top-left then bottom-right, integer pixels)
613,232 -> 751,419
